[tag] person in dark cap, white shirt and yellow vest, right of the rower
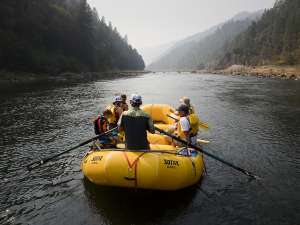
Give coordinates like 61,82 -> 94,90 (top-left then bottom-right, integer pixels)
175,104 -> 197,145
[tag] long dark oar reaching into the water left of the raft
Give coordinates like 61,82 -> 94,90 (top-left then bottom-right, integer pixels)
26,127 -> 118,170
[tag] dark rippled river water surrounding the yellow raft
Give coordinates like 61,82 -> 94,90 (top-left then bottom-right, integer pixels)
0,73 -> 300,225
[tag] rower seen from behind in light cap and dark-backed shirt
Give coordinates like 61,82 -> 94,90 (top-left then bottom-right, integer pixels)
118,94 -> 155,150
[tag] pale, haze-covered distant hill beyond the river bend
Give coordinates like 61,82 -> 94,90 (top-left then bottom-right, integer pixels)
147,10 -> 263,70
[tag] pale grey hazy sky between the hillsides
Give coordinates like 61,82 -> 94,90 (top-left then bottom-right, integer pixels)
88,0 -> 275,49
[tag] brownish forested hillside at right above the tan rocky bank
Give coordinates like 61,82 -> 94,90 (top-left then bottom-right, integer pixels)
218,0 -> 300,67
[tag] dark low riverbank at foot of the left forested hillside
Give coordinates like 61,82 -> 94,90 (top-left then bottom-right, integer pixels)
0,71 -> 149,86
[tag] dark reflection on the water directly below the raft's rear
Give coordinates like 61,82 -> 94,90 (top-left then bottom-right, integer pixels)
83,179 -> 197,225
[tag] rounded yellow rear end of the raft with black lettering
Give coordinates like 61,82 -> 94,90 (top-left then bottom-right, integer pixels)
81,145 -> 204,190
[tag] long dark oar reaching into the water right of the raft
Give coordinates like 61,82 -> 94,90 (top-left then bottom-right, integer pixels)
155,127 -> 259,179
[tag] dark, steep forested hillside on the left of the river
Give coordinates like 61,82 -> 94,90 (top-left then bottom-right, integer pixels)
0,0 -> 144,73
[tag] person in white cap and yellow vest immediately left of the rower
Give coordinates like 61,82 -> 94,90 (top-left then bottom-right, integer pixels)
103,96 -> 123,130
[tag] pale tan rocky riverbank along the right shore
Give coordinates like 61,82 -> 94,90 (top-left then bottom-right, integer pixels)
193,65 -> 300,80
